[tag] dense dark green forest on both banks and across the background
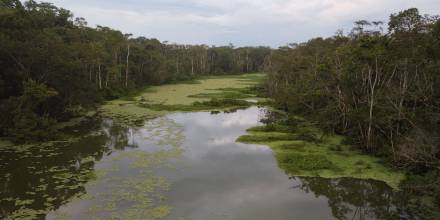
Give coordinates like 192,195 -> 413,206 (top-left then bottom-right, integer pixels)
0,0 -> 440,218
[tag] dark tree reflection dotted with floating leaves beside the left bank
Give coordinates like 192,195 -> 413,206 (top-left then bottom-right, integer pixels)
0,120 -> 136,219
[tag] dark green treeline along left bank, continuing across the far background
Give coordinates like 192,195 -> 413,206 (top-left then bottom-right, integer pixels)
0,0 -> 270,141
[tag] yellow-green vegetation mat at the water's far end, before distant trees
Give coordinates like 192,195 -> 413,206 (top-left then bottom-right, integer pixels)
99,73 -> 265,124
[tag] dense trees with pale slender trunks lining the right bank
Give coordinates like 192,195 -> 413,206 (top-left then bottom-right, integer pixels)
266,8 -> 440,219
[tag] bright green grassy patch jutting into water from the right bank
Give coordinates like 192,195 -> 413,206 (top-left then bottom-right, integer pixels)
237,121 -> 405,189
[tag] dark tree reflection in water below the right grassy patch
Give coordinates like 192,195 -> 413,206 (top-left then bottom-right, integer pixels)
292,177 -> 415,220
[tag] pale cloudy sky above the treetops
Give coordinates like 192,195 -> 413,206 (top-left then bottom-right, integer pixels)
46,0 -> 440,47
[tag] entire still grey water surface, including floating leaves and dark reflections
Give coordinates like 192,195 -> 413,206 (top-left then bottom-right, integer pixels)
0,107 -> 406,220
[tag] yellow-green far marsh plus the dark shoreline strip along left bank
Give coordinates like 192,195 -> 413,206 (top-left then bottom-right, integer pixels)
0,73 -> 265,147
